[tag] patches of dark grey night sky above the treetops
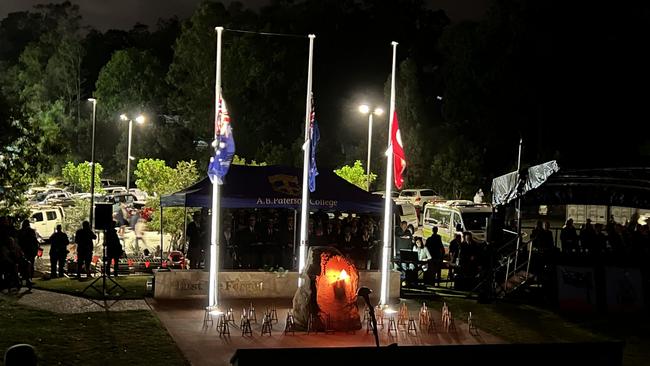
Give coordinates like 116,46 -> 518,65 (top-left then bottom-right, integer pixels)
0,0 -> 489,30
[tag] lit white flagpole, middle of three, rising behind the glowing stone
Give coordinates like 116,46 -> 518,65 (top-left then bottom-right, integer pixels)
298,34 -> 316,286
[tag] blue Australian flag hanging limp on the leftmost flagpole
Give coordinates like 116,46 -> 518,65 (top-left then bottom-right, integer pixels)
208,98 -> 235,184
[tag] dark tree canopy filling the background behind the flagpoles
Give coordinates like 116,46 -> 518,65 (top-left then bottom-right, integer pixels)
0,0 -> 650,202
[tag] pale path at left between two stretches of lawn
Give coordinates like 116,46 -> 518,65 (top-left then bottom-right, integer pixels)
0,288 -> 151,314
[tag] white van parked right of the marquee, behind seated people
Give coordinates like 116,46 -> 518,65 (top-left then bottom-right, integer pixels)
422,200 -> 492,246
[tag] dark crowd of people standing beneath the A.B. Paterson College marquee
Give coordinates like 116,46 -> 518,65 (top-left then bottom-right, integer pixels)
186,209 -> 380,270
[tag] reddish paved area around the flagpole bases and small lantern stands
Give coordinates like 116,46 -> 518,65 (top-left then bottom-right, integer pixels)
151,299 -> 503,366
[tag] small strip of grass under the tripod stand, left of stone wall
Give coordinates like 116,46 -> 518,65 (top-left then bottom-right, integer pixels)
34,275 -> 151,299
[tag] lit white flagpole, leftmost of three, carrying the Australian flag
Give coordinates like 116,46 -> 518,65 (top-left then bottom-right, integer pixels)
208,27 -> 223,307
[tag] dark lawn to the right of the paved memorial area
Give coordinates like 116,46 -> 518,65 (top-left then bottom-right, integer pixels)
422,296 -> 650,366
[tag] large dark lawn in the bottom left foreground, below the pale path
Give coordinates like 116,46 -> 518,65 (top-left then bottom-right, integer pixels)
0,299 -> 189,366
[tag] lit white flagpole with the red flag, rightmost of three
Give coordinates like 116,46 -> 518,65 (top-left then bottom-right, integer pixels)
379,42 -> 397,305
